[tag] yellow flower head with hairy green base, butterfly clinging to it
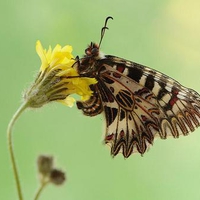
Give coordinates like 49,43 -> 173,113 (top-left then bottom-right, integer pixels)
24,41 -> 97,108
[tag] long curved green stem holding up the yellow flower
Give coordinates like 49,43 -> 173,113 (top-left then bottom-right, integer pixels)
7,102 -> 28,200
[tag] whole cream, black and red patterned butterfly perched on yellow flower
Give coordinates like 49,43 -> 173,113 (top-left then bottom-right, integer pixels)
73,17 -> 200,158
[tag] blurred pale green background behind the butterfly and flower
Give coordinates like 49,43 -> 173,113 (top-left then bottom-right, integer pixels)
0,0 -> 200,200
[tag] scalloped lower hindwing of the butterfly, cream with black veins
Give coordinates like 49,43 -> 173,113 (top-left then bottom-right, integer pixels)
97,61 -> 162,157
